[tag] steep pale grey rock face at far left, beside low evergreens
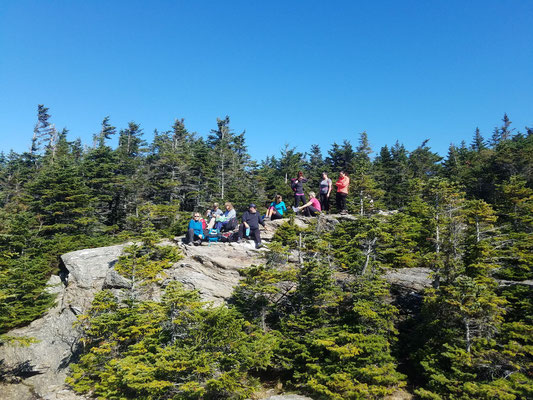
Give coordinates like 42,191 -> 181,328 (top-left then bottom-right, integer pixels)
0,246 -> 123,400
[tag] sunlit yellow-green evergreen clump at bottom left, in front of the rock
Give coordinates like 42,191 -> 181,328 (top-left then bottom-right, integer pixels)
67,282 -> 276,399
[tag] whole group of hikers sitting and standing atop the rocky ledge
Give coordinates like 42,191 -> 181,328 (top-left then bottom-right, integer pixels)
187,171 -> 350,248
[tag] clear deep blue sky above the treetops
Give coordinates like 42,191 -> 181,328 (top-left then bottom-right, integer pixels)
0,0 -> 533,160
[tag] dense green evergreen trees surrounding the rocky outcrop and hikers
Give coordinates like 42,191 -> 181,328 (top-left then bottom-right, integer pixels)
0,105 -> 533,399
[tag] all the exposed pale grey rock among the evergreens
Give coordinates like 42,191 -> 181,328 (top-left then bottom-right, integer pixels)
0,216 -> 430,400
